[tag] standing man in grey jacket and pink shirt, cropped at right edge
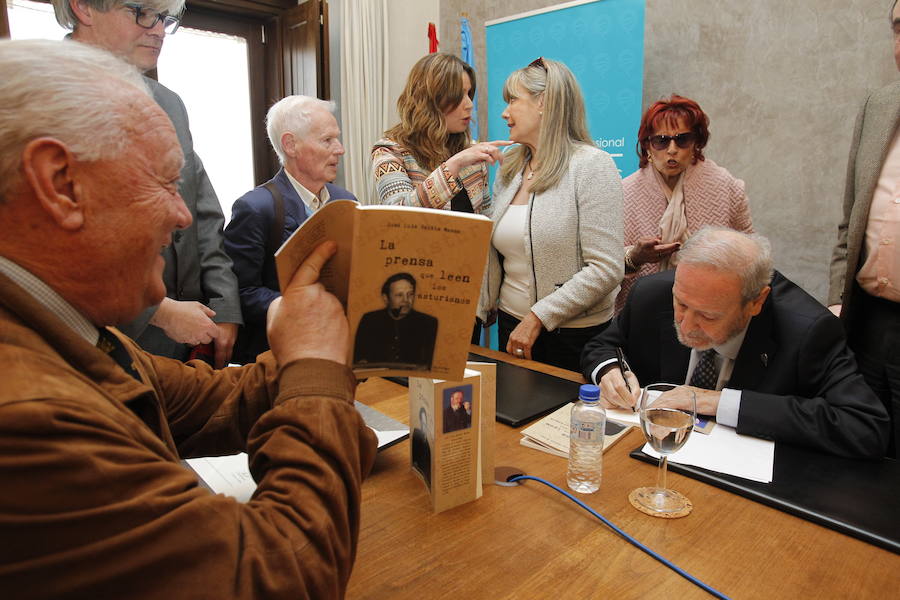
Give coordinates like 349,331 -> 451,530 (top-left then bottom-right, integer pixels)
828,0 -> 900,458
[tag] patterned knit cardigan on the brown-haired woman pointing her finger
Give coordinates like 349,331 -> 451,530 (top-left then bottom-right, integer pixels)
372,138 -> 491,216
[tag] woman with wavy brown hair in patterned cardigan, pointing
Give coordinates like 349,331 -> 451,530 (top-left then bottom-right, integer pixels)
372,53 -> 511,216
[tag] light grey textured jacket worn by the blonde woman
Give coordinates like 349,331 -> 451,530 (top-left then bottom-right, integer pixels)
478,144 -> 624,331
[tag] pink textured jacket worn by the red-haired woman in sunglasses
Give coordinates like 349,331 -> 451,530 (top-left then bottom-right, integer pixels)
616,159 -> 753,313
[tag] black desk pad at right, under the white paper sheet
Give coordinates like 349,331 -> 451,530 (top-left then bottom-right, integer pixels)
631,443 -> 900,553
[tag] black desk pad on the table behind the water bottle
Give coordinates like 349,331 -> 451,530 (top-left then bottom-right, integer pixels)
469,353 -> 579,427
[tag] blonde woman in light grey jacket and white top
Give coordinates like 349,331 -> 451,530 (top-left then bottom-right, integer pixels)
478,58 -> 624,371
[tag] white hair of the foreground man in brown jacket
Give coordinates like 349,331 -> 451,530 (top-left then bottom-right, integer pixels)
0,40 -> 149,201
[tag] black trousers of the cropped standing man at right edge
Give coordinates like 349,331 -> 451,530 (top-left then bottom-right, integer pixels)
847,287 -> 900,458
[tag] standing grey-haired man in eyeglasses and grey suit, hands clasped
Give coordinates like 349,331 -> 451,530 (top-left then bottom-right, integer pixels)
53,0 -> 242,368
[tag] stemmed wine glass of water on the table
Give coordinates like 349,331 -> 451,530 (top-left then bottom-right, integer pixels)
631,383 -> 697,515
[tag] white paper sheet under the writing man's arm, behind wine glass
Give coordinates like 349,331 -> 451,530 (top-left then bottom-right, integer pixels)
644,425 -> 775,483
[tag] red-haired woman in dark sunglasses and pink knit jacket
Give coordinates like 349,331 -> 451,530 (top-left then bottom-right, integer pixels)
616,95 -> 753,311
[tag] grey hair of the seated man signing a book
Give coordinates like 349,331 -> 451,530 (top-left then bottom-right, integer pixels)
678,225 -> 772,302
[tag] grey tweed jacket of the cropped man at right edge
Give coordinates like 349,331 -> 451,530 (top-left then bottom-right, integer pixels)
828,81 -> 900,319
